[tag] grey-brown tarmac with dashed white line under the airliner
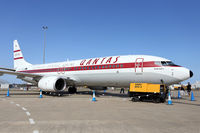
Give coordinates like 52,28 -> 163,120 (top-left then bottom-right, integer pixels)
0,89 -> 200,133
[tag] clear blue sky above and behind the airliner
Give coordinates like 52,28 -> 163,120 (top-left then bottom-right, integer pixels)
0,0 -> 200,82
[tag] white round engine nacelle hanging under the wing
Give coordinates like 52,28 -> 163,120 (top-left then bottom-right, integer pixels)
38,76 -> 66,91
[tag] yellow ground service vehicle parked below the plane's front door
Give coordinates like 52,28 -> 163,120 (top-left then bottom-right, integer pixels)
129,83 -> 167,103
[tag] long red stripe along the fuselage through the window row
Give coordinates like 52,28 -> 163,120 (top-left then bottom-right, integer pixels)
20,61 -> 180,73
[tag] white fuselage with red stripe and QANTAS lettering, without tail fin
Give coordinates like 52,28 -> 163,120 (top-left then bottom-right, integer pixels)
17,55 -> 190,87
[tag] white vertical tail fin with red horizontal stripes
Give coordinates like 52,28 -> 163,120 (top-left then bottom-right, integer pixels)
13,40 -> 31,70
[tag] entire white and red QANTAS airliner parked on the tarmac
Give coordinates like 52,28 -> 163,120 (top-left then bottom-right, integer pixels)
0,40 -> 193,93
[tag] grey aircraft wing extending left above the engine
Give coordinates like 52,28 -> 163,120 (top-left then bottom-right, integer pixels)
0,70 -> 43,78
